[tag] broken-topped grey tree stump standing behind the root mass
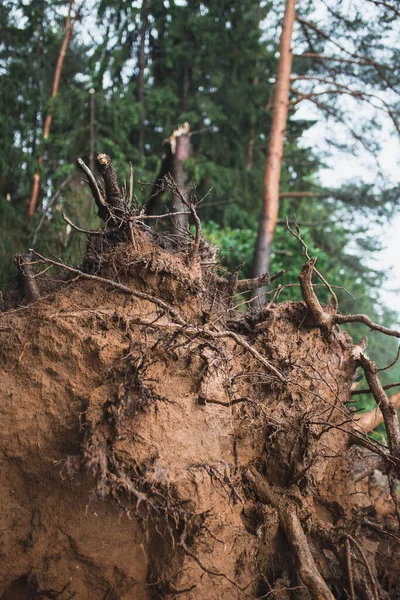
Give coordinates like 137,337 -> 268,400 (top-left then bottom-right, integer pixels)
171,123 -> 192,234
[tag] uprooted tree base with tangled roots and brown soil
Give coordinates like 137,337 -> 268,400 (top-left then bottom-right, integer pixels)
0,155 -> 400,600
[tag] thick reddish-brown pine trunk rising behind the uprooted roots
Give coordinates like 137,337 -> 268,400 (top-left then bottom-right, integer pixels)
253,0 -> 296,295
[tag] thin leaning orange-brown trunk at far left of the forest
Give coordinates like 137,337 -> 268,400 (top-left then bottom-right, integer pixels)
28,0 -> 83,217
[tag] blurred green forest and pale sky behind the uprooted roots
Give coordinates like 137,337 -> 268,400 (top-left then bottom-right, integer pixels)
0,0 -> 400,432
